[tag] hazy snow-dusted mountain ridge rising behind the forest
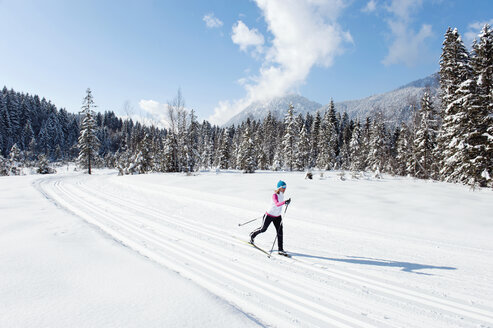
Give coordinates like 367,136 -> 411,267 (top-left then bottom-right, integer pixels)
225,73 -> 439,126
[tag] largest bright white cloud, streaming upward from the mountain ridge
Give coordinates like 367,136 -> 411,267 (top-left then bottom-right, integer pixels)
209,0 -> 353,124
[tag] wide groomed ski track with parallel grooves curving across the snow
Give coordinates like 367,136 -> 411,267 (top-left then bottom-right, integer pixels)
36,175 -> 493,327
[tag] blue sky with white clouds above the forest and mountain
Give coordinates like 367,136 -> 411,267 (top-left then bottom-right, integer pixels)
0,0 -> 493,124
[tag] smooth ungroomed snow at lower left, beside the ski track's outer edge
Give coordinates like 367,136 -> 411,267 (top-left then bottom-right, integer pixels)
0,176 -> 260,328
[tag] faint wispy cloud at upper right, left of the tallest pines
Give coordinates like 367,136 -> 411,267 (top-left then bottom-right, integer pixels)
382,0 -> 433,67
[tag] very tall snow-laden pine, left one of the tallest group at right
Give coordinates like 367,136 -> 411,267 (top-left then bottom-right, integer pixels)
438,28 -> 471,182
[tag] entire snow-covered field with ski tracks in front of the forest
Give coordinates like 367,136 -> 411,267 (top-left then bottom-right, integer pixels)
0,170 -> 493,328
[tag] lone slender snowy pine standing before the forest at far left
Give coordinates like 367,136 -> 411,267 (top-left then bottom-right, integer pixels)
78,88 -> 99,174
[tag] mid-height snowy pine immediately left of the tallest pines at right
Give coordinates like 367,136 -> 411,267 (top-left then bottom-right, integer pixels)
414,92 -> 438,179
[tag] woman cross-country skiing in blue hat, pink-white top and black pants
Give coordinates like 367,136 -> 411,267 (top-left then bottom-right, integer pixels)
250,180 -> 291,256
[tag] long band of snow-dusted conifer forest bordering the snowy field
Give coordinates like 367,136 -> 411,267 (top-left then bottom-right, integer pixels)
0,25 -> 493,187
